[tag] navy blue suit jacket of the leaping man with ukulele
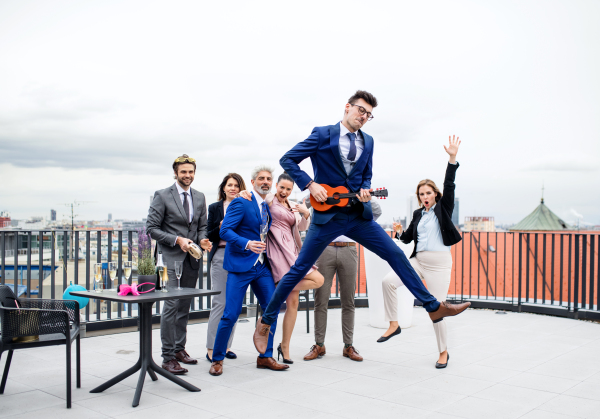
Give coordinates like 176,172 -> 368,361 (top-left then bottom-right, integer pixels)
279,123 -> 373,224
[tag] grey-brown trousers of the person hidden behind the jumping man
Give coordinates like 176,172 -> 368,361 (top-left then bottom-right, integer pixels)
314,246 -> 358,345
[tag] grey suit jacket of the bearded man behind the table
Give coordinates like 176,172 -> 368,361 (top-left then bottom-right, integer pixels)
146,184 -> 207,269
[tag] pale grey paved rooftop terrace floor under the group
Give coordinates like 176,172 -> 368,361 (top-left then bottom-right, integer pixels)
0,308 -> 600,419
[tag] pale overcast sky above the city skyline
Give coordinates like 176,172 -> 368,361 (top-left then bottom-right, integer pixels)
0,0 -> 600,224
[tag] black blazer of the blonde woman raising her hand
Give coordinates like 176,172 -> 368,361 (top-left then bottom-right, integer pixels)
400,162 -> 462,258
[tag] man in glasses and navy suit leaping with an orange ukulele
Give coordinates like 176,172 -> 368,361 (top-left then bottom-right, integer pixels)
254,90 -> 470,356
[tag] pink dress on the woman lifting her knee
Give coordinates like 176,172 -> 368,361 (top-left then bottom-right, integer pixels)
267,194 -> 317,283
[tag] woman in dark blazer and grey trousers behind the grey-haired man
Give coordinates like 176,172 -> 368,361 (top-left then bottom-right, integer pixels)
206,173 -> 246,362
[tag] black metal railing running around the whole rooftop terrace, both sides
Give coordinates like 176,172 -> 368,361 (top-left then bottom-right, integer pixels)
0,230 -> 600,330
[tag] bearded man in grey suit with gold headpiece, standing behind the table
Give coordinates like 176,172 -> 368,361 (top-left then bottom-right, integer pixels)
146,154 -> 212,374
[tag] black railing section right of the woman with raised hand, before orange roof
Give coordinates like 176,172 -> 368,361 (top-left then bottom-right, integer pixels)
448,232 -> 600,319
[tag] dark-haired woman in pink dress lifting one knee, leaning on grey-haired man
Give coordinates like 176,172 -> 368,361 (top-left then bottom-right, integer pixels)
240,173 -> 324,364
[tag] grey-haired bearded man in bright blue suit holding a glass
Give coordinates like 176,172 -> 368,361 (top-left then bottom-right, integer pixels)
209,166 -> 289,375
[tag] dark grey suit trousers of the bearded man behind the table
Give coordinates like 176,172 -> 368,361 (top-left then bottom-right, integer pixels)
158,254 -> 199,362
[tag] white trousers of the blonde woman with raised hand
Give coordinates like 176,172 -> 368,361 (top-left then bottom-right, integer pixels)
382,252 -> 452,353
